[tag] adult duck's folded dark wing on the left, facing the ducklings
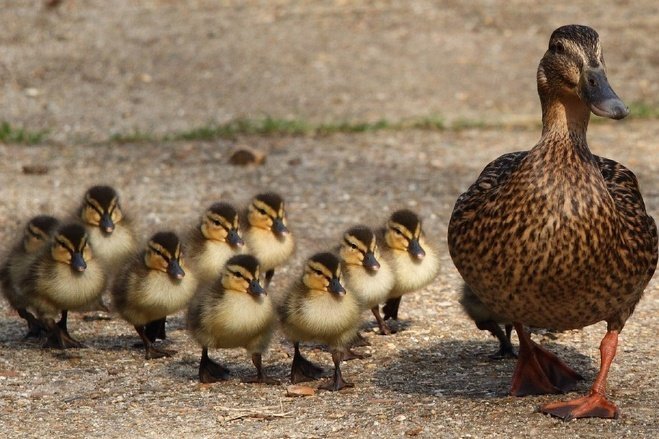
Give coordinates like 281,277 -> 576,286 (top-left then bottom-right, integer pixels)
451,151 -> 528,222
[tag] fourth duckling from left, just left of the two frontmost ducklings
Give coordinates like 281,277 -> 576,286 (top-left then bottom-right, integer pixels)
112,232 -> 197,360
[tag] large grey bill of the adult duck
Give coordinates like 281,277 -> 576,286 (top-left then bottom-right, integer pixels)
578,67 -> 629,119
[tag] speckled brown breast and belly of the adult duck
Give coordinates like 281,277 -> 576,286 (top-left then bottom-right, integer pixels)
452,162 -> 637,329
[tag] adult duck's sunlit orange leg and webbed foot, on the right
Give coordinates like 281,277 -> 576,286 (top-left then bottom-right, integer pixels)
540,330 -> 620,421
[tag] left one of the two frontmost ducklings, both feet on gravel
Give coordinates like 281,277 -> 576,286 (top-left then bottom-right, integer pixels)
188,255 -> 279,384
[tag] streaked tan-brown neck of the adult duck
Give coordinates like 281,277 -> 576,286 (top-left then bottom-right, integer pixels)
538,96 -> 593,162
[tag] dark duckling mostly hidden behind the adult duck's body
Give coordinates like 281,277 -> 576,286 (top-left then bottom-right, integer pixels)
460,284 -> 517,360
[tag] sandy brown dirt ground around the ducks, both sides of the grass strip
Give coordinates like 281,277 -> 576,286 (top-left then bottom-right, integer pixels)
0,0 -> 659,438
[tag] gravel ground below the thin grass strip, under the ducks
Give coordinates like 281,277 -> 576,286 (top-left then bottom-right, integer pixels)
0,122 -> 659,437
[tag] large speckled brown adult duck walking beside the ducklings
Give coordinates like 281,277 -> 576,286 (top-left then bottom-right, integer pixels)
448,25 -> 657,419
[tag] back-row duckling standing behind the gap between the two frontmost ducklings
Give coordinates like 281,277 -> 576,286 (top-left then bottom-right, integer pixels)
243,192 -> 295,288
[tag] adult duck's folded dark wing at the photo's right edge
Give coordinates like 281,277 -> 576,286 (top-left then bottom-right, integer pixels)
594,156 -> 658,276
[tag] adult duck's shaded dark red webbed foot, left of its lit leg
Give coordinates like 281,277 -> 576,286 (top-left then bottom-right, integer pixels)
510,323 -> 583,396
